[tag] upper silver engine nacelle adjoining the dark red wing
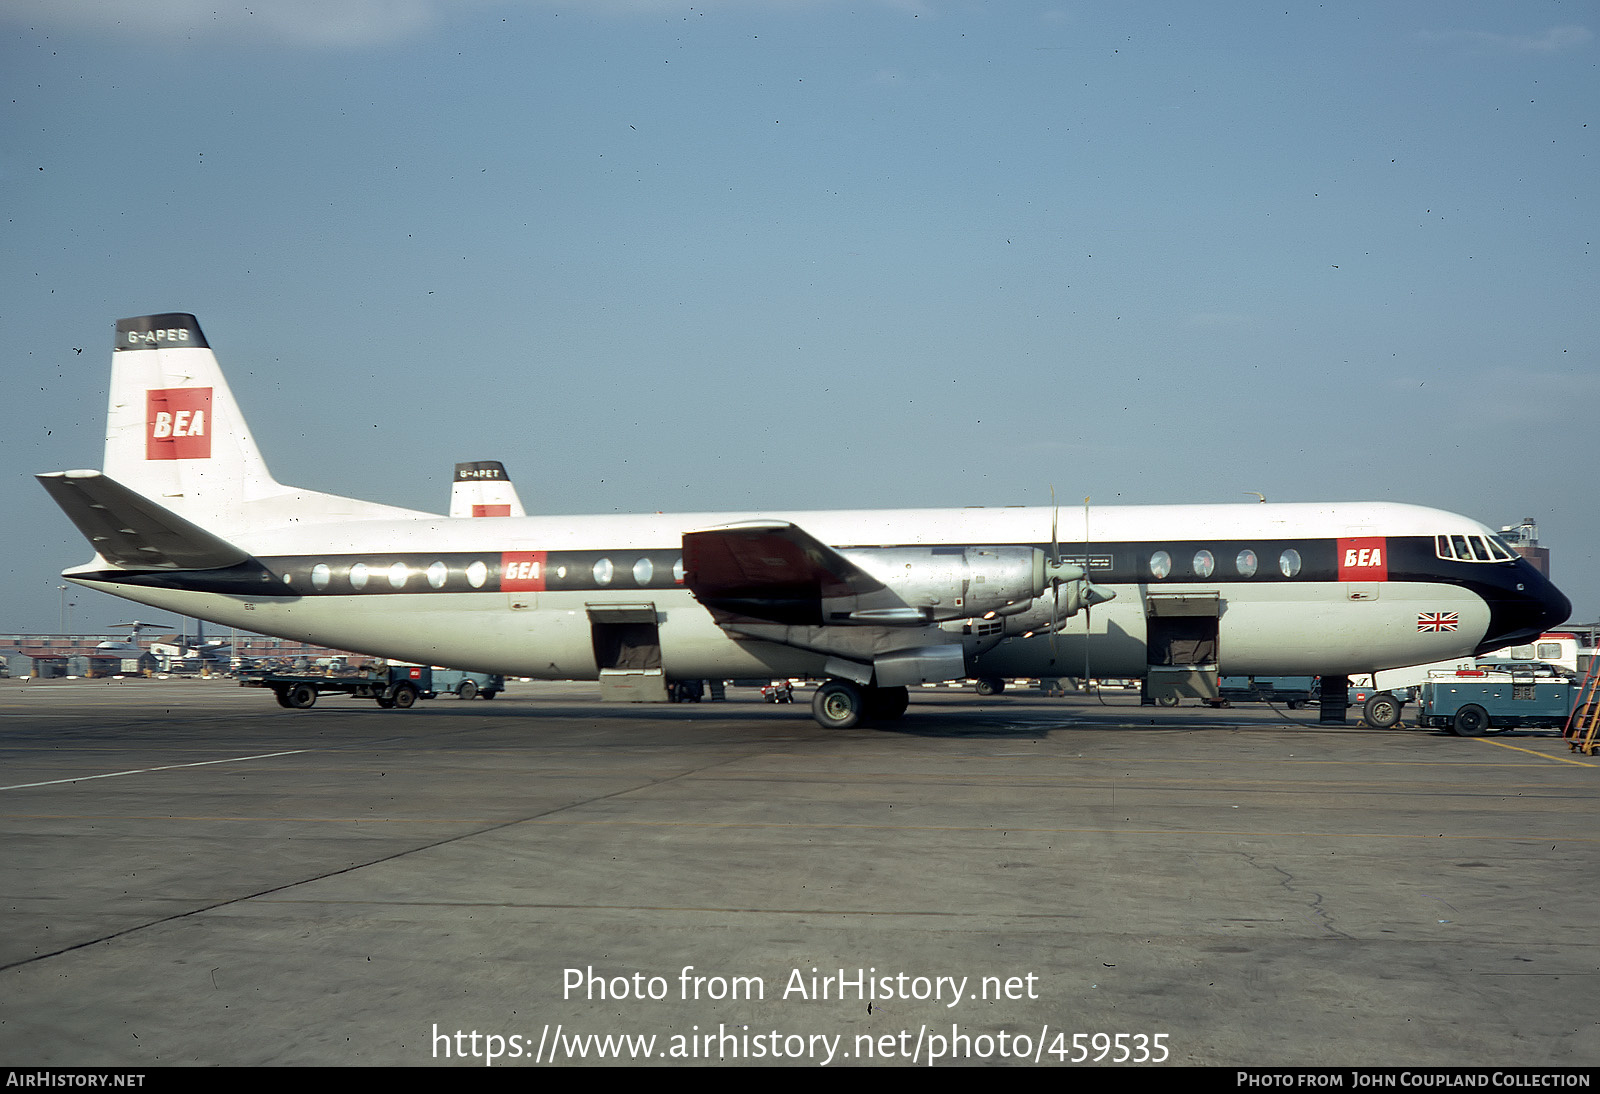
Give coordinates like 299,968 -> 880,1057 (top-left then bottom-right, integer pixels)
838,547 -> 1046,622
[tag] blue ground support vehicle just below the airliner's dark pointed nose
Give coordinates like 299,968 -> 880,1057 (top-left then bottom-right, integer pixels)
1418,669 -> 1579,737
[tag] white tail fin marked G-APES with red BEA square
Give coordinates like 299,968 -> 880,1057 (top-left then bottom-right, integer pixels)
106,312 -> 430,536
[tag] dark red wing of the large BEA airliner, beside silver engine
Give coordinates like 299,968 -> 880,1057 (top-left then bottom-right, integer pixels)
683,521 -> 883,624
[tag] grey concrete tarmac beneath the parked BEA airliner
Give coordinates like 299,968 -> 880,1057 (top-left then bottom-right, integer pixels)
0,680 -> 1600,1068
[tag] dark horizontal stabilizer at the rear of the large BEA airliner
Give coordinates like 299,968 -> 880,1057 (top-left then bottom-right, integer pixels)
35,470 -> 250,569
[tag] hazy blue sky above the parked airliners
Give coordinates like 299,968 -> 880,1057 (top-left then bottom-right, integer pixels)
0,0 -> 1600,632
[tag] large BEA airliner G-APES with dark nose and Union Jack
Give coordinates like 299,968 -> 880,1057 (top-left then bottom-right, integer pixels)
38,313 -> 1571,728
